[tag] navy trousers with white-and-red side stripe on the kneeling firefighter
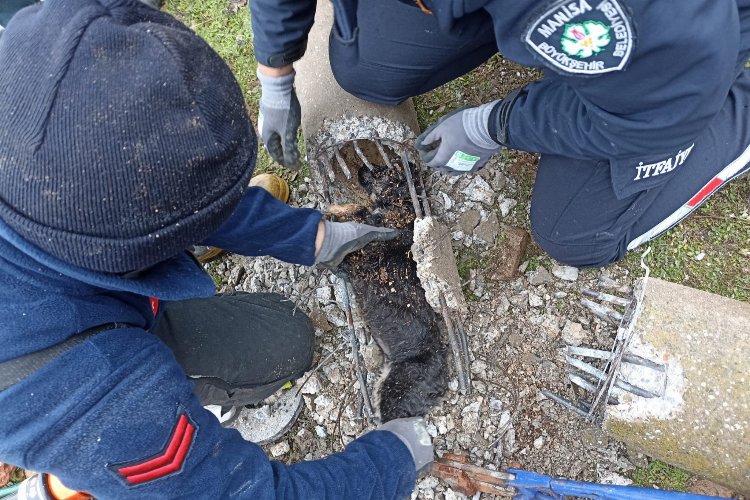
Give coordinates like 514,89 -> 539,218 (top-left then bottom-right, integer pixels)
329,0 -> 750,267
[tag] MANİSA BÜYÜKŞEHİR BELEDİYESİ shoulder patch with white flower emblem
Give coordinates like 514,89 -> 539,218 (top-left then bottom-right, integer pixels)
523,0 -> 635,75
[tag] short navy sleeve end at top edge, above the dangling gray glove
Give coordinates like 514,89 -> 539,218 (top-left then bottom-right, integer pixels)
249,0 -> 316,68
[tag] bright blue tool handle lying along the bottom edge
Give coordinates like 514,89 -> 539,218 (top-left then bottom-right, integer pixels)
508,469 -> 719,500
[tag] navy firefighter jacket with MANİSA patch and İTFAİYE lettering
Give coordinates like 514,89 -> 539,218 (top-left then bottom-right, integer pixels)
250,0 -> 750,199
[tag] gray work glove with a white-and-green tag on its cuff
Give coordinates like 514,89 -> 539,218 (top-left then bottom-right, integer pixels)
414,101 -> 502,175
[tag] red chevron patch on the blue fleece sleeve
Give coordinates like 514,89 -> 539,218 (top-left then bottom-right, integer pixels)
112,413 -> 195,486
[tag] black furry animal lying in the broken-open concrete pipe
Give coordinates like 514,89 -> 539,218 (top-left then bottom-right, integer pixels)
334,141 -> 447,422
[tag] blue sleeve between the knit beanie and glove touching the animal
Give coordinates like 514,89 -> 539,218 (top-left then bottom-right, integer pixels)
204,187 -> 322,266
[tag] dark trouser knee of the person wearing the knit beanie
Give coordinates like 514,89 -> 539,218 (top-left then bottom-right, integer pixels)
153,292 -> 314,406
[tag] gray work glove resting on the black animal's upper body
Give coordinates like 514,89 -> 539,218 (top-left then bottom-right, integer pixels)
315,220 -> 399,267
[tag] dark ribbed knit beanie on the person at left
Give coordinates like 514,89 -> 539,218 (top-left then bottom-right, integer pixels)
0,0 -> 257,273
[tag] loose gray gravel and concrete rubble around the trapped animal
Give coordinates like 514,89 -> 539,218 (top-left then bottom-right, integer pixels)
211,155 -> 640,500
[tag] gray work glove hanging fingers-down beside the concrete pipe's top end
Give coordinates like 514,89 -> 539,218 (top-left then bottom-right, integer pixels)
256,71 -> 302,170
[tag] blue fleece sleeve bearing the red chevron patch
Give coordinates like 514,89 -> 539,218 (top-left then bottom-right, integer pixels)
0,329 -> 415,500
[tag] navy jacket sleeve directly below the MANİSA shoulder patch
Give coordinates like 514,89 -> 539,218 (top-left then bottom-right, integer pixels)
507,1 -> 739,159
